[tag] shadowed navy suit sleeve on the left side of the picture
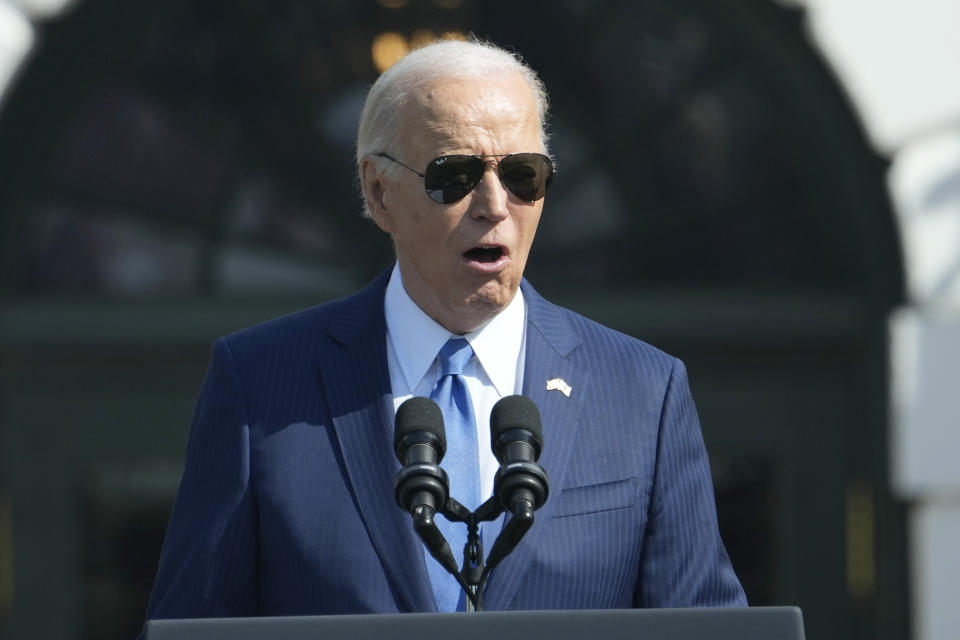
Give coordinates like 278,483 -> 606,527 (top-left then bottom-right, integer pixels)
141,338 -> 258,619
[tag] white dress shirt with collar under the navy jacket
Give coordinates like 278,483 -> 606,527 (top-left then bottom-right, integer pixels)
384,265 -> 526,510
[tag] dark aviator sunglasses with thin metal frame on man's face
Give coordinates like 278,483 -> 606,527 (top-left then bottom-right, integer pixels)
376,152 -> 556,204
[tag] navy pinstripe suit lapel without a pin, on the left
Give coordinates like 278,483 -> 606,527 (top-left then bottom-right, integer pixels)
319,271 -> 436,611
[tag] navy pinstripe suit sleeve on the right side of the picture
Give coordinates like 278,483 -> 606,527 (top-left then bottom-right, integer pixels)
634,360 -> 747,607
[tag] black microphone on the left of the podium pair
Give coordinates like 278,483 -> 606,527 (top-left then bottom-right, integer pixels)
393,396 -> 458,575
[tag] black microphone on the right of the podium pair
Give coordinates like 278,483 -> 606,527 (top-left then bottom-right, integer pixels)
490,396 -> 549,517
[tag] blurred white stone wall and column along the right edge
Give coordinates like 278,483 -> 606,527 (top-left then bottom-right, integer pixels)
791,0 -> 960,640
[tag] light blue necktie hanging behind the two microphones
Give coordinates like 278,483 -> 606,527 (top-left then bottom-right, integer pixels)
427,338 -> 480,611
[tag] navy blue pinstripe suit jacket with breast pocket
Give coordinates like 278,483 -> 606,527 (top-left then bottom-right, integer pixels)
147,272 -> 746,618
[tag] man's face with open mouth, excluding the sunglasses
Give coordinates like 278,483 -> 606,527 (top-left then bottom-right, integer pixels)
364,73 -> 543,333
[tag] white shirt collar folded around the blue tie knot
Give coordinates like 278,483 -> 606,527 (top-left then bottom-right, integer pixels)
384,265 -> 526,396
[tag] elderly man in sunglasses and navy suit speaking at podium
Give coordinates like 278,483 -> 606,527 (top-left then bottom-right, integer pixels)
142,37 -> 746,618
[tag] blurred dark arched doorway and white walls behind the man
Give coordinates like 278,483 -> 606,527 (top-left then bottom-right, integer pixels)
0,0 -> 960,640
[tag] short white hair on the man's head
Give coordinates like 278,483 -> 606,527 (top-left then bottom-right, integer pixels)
357,37 -> 549,217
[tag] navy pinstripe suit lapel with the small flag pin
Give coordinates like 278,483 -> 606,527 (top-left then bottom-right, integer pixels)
485,281 -> 590,610
